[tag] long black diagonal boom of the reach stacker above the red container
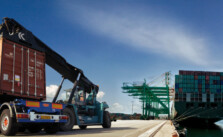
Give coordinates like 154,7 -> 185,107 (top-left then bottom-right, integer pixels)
0,18 -> 95,90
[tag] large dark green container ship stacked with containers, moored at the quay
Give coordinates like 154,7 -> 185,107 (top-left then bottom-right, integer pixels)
174,70 -> 223,125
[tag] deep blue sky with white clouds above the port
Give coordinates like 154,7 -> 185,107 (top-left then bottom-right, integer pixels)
0,0 -> 223,113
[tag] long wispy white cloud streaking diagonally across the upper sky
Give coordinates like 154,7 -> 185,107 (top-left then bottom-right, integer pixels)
62,4 -> 210,65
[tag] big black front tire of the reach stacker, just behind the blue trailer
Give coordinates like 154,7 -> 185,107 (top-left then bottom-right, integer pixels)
60,108 -> 76,131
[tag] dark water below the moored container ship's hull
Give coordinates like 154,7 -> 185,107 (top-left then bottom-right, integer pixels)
187,120 -> 223,137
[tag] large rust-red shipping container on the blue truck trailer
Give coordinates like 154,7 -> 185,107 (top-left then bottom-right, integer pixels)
0,38 -> 46,100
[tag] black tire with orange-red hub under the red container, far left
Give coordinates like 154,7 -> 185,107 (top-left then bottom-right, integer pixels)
0,109 -> 18,136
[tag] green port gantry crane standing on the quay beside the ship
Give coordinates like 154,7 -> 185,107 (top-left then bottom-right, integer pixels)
122,72 -> 173,119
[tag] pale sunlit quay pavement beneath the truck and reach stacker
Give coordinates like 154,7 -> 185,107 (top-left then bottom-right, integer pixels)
1,120 -> 171,137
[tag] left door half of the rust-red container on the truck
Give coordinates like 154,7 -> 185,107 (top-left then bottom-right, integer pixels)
1,40 -> 24,94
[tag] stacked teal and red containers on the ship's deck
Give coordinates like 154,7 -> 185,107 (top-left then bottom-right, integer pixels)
175,70 -> 223,102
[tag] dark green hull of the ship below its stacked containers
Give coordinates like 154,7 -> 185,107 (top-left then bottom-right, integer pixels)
175,101 -> 223,126
